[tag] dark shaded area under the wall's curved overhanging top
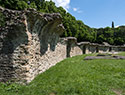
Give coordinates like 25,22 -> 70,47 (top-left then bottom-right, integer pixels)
27,13 -> 63,56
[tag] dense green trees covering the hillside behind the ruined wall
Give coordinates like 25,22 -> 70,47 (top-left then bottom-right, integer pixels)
0,0 -> 125,45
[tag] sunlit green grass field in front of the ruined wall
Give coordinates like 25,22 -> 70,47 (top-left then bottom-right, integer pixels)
0,53 -> 125,95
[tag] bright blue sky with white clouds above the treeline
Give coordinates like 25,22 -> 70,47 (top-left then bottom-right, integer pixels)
47,0 -> 125,28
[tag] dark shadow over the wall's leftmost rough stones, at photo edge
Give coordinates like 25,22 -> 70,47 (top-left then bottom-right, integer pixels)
0,26 -> 28,82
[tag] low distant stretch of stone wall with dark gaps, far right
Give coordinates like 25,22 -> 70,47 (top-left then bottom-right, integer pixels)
78,42 -> 125,54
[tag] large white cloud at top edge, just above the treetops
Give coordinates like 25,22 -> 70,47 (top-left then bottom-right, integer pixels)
45,0 -> 70,10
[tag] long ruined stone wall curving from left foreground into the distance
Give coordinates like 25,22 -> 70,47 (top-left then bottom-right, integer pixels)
0,7 -> 125,83
